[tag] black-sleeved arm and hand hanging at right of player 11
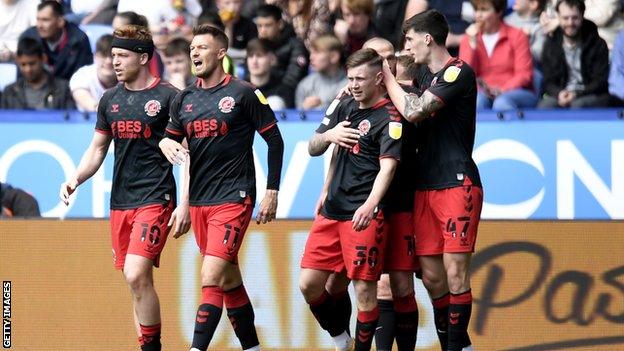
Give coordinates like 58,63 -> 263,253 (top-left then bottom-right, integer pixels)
256,124 -> 284,224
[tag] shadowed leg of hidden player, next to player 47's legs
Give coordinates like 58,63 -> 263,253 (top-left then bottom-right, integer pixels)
390,271 -> 418,351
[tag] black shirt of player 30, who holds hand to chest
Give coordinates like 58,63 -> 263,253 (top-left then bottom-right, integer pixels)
316,97 -> 403,220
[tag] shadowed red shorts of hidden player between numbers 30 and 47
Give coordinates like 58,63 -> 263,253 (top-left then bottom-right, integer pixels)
384,212 -> 420,272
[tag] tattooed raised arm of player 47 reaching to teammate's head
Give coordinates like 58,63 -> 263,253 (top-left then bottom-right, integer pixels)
383,61 -> 444,123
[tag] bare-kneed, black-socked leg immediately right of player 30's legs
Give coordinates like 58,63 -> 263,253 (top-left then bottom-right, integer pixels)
375,274 -> 395,351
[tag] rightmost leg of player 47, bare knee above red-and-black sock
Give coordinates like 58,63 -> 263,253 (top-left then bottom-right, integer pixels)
444,253 -> 472,351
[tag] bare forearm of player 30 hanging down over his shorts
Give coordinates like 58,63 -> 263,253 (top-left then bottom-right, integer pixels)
352,157 -> 398,231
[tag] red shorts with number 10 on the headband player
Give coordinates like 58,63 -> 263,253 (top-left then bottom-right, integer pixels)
110,203 -> 173,269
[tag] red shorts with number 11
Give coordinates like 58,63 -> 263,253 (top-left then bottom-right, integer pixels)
190,200 -> 253,264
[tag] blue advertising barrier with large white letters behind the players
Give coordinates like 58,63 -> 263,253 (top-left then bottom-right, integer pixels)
0,110 -> 624,219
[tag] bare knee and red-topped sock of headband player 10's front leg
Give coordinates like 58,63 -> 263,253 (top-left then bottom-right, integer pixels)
123,254 -> 161,350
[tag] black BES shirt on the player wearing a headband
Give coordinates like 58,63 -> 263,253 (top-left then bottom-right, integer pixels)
95,79 -> 178,209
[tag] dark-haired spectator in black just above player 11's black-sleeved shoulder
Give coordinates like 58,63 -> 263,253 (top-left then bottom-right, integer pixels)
247,38 -> 293,110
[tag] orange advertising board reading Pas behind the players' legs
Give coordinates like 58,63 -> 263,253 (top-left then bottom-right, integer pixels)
0,220 -> 624,351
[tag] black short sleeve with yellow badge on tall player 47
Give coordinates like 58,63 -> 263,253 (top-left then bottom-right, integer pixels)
427,61 -> 477,103
